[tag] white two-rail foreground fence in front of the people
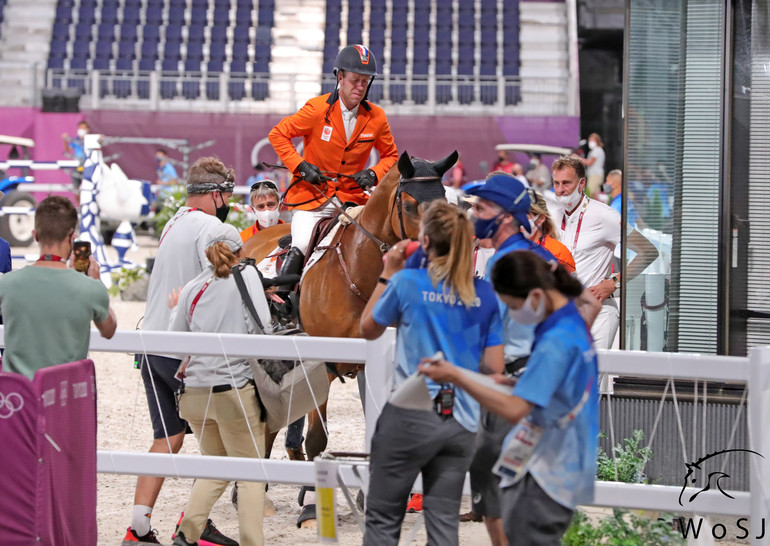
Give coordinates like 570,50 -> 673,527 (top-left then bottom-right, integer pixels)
0,327 -> 770,544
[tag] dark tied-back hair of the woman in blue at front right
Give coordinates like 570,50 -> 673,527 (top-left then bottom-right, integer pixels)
492,250 -> 583,299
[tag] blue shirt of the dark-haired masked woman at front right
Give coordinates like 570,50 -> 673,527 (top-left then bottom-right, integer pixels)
500,302 -> 599,509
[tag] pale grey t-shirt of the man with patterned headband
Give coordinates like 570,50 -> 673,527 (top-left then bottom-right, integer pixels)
142,206 -> 228,331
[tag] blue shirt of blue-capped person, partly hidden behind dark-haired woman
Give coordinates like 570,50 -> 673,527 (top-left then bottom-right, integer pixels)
484,233 -> 556,362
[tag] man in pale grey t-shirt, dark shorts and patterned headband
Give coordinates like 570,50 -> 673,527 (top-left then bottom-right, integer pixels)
123,157 -> 235,544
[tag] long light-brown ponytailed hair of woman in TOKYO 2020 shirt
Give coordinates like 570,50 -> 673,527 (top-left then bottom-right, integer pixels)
422,201 -> 476,307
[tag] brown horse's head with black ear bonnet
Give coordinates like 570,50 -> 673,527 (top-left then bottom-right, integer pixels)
390,150 -> 458,239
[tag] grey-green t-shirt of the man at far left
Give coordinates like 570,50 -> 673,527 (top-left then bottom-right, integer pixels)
0,266 -> 110,379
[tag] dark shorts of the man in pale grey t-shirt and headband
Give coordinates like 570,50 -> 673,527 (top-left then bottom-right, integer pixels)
136,355 -> 187,440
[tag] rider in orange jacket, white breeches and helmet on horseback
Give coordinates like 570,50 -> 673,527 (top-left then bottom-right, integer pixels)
269,45 -> 398,274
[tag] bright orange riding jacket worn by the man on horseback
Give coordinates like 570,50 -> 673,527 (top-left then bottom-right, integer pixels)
268,93 -> 398,210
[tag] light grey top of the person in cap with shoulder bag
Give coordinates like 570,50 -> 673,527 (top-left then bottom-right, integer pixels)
169,265 -> 270,387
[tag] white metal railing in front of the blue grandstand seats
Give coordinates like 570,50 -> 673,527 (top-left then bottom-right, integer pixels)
45,69 -> 574,116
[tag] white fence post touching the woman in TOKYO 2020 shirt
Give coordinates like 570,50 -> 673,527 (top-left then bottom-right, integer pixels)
364,328 -> 396,453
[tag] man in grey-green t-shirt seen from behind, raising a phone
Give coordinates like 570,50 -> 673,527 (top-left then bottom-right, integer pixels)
0,196 -> 117,379
